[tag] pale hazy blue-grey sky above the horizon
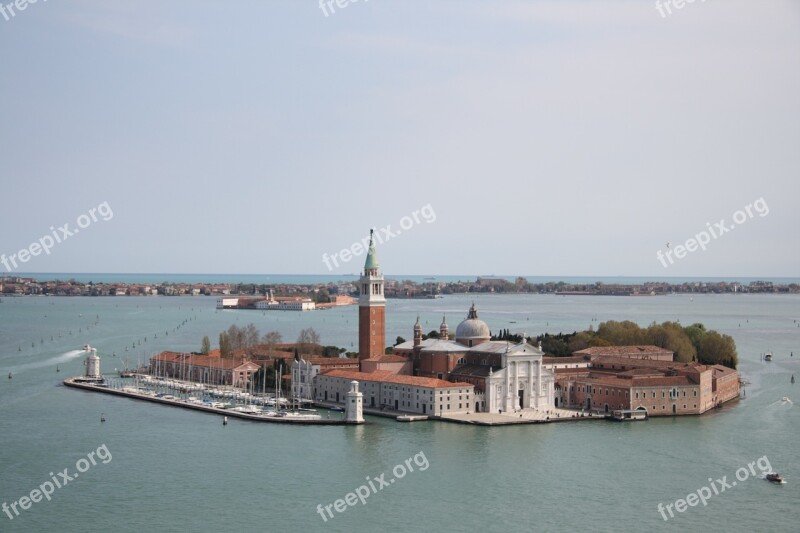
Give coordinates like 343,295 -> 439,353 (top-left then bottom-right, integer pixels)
0,0 -> 800,277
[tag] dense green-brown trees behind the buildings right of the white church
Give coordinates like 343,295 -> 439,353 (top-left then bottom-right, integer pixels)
536,320 -> 739,368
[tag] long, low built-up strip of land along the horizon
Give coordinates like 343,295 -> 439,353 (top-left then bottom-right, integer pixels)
0,274 -> 800,296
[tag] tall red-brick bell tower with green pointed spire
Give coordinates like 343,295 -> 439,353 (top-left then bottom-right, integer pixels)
358,230 -> 386,361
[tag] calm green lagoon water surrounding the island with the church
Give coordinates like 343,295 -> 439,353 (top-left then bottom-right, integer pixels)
0,295 -> 800,532
